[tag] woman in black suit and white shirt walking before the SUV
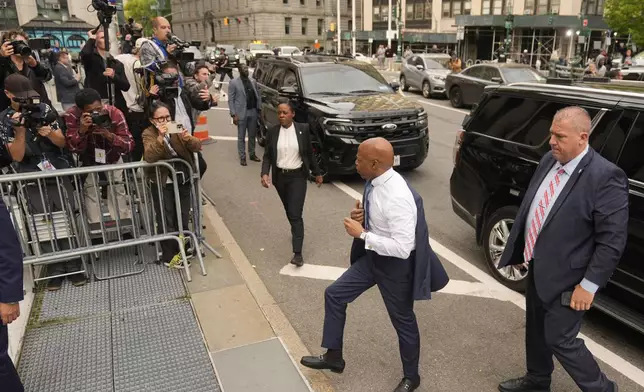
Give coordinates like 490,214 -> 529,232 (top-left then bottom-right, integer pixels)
262,101 -> 323,267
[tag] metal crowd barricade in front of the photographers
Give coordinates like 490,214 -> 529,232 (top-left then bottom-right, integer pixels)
0,160 -> 213,281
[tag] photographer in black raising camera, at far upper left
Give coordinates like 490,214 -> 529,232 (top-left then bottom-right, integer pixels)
0,30 -> 51,110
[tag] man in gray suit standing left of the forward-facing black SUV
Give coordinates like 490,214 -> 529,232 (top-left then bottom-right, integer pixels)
228,64 -> 262,166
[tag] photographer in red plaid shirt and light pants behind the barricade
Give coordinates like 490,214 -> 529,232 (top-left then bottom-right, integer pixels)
65,88 -> 134,230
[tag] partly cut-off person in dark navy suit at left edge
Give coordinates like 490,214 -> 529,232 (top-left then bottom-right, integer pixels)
0,198 -> 24,392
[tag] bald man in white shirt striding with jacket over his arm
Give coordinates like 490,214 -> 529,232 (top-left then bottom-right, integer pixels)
301,138 -> 449,392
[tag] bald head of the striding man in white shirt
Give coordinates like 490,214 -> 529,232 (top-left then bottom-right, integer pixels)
356,137 -> 394,180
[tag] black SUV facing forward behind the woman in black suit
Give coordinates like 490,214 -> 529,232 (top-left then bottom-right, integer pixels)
253,55 -> 429,178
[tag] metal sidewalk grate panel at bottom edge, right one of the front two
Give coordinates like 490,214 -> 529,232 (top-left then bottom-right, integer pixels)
112,300 -> 220,392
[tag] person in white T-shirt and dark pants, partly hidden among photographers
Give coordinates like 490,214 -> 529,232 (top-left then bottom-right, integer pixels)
116,38 -> 148,162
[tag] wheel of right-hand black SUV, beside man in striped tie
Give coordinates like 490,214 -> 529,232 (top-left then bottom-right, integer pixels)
483,206 -> 528,292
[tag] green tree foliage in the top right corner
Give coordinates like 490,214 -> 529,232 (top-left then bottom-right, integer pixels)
604,0 -> 644,47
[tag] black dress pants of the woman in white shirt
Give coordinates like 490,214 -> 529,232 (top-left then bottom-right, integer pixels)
274,169 -> 307,253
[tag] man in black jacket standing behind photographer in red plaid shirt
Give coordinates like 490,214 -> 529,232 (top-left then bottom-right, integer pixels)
81,28 -> 130,110
